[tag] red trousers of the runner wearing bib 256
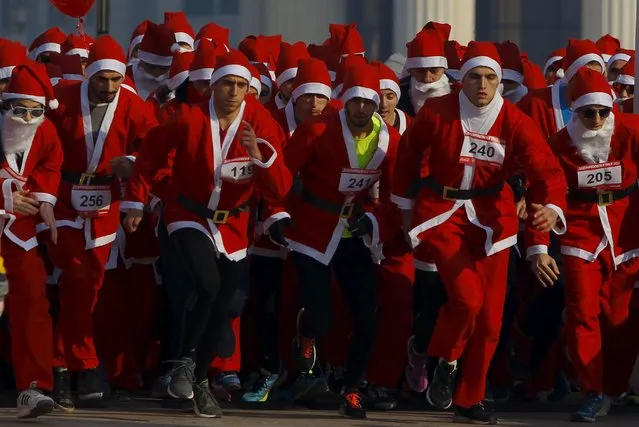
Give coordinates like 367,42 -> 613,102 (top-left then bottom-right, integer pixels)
47,227 -> 111,371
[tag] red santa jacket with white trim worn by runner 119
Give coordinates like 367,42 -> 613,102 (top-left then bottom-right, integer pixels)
122,98 -> 291,261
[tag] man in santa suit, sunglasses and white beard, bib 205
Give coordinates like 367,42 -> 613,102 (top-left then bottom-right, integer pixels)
527,68 -> 639,422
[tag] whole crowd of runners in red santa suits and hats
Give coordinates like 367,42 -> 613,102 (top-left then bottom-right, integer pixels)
0,12 -> 639,424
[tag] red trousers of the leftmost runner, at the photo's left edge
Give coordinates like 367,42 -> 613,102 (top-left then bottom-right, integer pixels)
2,236 -> 53,391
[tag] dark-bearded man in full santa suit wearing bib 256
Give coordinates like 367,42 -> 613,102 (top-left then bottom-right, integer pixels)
47,36 -> 157,411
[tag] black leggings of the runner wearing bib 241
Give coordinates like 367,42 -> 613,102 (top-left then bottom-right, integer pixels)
292,238 -> 379,390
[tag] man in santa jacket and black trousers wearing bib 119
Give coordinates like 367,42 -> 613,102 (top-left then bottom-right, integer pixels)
123,51 -> 291,418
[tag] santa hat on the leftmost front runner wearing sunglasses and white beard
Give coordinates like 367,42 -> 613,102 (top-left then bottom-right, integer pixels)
2,61 -> 60,110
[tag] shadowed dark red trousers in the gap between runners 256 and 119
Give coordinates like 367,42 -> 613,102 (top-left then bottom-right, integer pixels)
94,263 -> 157,390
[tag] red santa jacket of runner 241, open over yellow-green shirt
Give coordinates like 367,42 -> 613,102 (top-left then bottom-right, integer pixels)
272,110 -> 399,265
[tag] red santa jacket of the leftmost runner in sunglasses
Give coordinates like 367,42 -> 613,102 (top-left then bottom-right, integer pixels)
0,118 -> 62,251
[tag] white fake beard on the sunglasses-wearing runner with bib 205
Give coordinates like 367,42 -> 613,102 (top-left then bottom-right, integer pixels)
566,112 -> 615,164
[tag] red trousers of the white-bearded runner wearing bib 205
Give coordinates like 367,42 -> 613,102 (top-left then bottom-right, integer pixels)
564,252 -> 636,393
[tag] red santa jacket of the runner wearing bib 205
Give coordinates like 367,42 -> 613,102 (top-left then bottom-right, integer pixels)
526,113 -> 639,265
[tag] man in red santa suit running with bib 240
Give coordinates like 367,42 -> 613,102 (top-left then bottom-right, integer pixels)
392,42 -> 566,424
